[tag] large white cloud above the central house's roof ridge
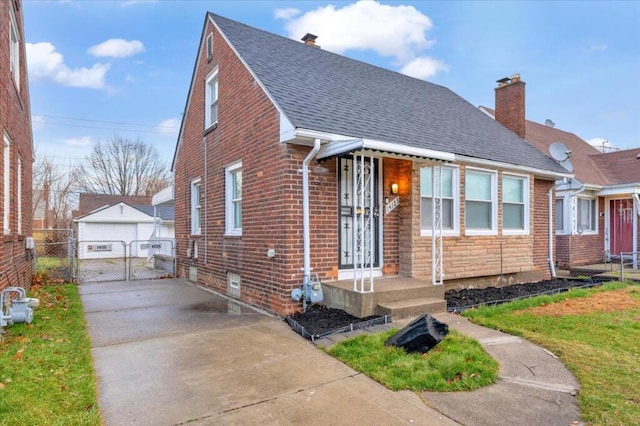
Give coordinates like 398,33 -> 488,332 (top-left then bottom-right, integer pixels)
276,1 -> 440,65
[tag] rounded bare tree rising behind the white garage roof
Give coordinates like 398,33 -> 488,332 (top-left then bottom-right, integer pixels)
80,136 -> 171,196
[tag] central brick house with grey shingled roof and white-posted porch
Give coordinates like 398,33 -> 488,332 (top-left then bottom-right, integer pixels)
172,13 -> 571,316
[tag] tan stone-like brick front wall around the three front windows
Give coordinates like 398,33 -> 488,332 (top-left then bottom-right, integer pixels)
399,163 -> 552,288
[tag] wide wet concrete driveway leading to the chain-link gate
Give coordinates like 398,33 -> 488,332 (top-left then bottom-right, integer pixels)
80,279 -> 456,426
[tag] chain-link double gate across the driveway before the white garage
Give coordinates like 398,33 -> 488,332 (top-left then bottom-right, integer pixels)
77,239 -> 175,283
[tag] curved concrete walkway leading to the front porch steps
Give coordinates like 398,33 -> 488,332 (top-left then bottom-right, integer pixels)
316,313 -> 581,426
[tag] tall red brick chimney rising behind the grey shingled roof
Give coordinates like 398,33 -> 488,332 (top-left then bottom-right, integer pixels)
495,74 -> 525,138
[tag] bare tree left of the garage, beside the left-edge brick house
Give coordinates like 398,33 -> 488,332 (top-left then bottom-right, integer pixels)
32,155 -> 78,228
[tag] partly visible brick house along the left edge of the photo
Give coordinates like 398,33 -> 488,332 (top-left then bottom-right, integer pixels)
0,0 -> 33,289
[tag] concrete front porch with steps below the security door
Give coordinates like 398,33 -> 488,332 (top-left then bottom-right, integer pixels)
322,276 -> 447,320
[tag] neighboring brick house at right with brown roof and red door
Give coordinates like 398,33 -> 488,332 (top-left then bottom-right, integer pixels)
480,76 -> 640,269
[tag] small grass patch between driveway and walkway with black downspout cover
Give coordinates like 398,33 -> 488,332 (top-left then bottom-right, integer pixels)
328,330 -> 498,392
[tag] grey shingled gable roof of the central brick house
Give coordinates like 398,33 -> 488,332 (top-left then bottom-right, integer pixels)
208,13 -> 566,174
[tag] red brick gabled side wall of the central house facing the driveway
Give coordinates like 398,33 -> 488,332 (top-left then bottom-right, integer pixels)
175,20 -> 338,315
